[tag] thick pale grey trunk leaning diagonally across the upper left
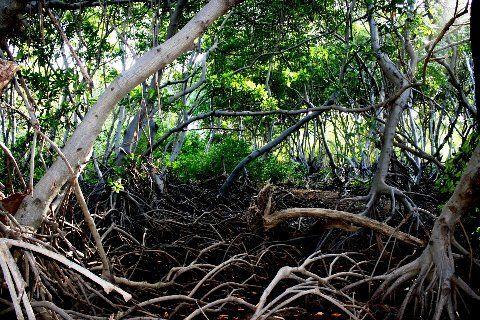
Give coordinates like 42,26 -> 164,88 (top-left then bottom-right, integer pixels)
16,0 -> 242,228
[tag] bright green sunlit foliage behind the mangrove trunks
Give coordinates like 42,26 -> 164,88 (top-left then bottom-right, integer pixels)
0,0 -> 473,200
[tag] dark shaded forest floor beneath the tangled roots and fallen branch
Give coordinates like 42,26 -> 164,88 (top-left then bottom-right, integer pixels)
12,177 -> 480,319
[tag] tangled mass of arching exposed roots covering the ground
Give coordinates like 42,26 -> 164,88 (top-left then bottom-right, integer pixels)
0,175 -> 478,320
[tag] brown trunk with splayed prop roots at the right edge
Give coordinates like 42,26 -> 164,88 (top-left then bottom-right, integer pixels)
374,0 -> 480,320
